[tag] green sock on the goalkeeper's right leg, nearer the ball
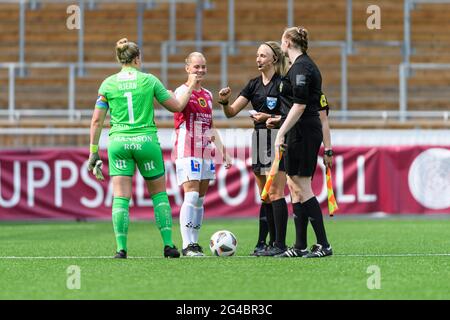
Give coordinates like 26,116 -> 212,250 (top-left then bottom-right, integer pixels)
152,192 -> 173,247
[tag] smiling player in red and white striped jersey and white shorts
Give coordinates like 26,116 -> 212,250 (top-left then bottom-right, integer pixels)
174,52 -> 231,257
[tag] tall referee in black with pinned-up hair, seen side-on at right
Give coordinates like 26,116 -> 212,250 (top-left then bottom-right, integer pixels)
275,27 -> 333,258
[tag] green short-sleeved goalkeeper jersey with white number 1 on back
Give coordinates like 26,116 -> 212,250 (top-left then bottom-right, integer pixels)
95,67 -> 171,136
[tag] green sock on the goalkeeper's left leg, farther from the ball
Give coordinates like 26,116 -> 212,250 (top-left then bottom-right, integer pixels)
112,197 -> 130,252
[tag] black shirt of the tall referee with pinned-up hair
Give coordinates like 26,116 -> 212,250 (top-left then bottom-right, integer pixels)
279,53 -> 322,120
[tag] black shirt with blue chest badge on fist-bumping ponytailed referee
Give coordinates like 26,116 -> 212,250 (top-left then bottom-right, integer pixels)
239,73 -> 281,129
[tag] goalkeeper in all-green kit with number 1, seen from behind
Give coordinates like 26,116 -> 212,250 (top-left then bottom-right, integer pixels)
88,38 -> 197,259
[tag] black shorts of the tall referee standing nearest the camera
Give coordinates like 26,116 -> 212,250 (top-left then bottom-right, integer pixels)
284,117 -> 323,178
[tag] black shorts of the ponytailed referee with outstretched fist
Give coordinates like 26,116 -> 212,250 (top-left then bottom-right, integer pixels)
252,129 -> 285,175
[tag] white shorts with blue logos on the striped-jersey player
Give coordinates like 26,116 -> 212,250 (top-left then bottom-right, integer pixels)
175,157 -> 216,186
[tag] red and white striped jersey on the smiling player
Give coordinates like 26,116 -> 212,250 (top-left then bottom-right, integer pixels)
174,84 -> 213,159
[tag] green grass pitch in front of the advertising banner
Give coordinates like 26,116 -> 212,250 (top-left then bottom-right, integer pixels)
0,217 -> 450,300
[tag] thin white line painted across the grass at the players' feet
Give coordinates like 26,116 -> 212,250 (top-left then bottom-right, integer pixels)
0,253 -> 450,260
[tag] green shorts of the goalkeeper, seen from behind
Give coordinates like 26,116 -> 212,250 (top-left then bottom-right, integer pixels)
108,133 -> 165,180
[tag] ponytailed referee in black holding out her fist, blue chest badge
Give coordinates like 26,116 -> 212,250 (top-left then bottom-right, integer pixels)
219,41 -> 288,256
